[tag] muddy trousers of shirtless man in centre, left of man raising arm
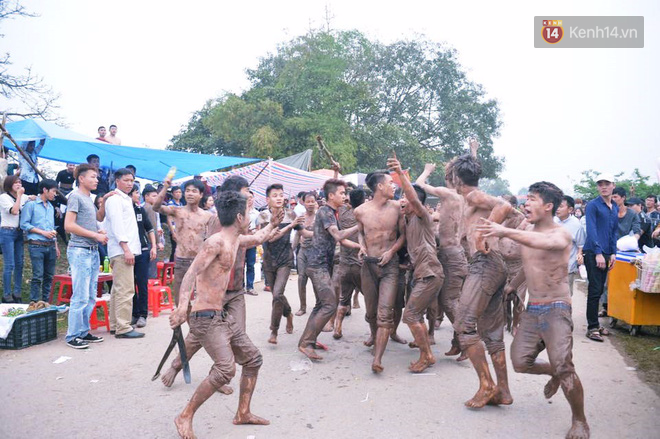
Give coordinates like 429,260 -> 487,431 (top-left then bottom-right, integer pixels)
361,256 -> 399,328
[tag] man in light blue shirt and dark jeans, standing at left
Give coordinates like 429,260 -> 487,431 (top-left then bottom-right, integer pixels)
21,180 -> 60,302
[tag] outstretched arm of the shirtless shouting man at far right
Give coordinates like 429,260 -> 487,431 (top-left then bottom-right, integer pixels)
477,218 -> 572,250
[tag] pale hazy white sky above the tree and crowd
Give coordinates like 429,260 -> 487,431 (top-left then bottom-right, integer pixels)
0,0 -> 660,192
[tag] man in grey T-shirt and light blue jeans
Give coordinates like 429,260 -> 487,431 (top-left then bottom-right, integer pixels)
64,164 -> 108,349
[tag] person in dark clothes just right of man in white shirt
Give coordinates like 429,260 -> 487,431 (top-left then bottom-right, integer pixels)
129,185 -> 156,328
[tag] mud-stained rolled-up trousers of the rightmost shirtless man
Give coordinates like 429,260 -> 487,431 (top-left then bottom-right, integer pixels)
511,302 -> 575,377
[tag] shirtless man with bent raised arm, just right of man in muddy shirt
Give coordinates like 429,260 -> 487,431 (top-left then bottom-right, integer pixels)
416,164 -> 468,361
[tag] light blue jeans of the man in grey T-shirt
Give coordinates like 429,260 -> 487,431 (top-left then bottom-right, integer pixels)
66,247 -> 99,342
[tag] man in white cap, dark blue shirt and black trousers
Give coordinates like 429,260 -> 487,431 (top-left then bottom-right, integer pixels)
583,174 -> 619,342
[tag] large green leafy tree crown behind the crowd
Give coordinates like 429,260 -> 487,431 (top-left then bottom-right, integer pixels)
170,31 -> 503,179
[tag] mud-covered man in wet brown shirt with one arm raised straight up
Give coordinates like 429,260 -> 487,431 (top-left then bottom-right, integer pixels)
387,158 -> 445,373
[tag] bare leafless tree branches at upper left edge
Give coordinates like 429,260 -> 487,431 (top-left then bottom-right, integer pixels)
0,0 -> 59,120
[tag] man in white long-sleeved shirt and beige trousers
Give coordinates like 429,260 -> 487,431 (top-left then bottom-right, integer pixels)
105,168 -> 144,338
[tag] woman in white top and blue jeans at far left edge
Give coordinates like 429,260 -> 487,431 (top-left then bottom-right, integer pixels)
0,175 -> 30,303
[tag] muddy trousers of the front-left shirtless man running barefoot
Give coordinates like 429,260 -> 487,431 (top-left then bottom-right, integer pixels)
186,311 -> 263,390
